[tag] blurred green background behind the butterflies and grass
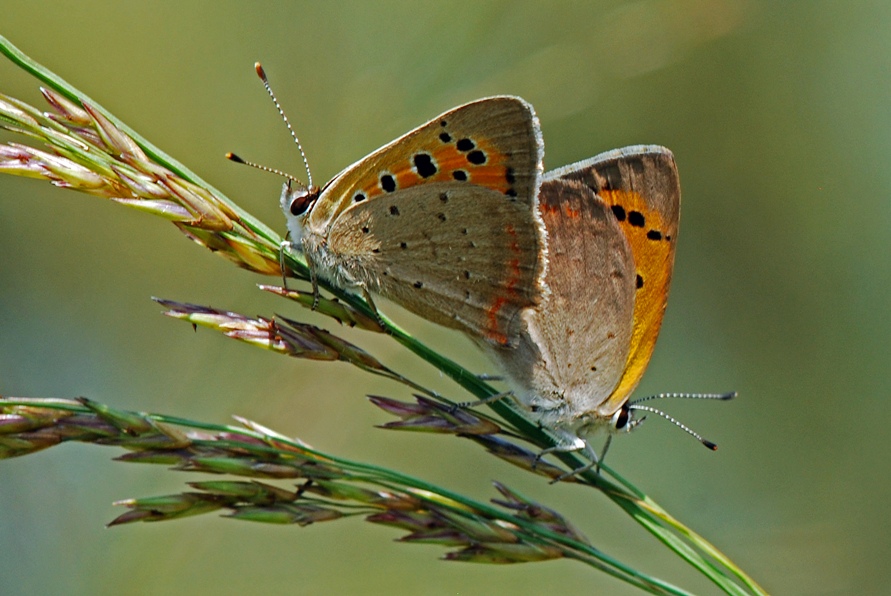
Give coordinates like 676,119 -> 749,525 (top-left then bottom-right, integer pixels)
0,0 -> 891,594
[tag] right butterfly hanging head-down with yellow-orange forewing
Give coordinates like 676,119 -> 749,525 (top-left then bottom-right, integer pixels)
483,146 -> 684,462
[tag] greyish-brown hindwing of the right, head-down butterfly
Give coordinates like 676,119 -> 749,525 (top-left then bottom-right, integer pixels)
478,179 -> 634,415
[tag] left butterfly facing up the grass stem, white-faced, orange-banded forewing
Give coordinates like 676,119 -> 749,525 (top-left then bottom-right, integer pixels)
281,96 -> 547,346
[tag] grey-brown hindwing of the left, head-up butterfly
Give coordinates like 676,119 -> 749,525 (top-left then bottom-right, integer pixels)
328,182 -> 542,345
